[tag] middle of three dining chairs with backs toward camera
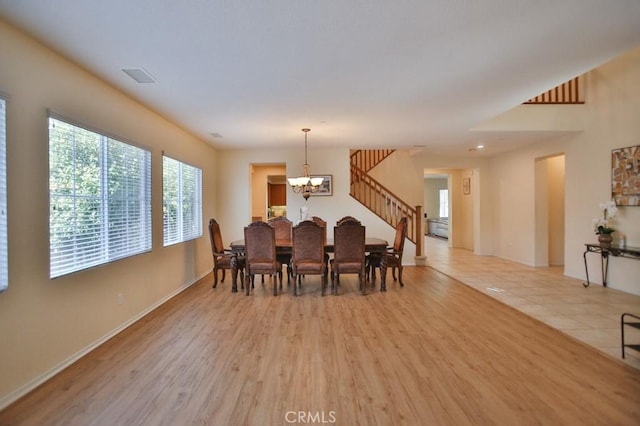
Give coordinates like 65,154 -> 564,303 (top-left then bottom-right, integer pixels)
291,220 -> 327,296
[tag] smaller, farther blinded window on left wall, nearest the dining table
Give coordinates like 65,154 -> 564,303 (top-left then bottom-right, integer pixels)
162,156 -> 202,246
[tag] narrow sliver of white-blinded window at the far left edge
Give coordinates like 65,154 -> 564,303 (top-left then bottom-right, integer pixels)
0,98 -> 9,291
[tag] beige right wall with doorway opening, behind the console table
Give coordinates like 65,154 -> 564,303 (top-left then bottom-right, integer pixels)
491,49 -> 640,294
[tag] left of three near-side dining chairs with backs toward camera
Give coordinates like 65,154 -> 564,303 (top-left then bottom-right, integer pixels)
244,221 -> 282,296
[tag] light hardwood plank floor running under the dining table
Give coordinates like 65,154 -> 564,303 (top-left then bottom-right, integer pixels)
0,245 -> 640,425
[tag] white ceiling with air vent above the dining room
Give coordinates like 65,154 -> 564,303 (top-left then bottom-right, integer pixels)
0,0 -> 640,153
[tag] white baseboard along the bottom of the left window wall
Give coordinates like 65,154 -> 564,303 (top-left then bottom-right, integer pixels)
0,271 -> 206,410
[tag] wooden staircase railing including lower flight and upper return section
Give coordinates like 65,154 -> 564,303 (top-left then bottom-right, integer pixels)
350,149 -> 423,256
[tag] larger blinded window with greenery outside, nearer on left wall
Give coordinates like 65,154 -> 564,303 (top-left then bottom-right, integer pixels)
49,116 -> 151,278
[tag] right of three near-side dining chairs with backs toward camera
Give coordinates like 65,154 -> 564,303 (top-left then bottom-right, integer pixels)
331,220 -> 365,294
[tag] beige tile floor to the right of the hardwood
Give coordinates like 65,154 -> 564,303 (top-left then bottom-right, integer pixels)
424,237 -> 640,369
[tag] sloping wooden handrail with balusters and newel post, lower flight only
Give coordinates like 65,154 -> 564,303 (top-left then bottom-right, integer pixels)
350,164 -> 422,256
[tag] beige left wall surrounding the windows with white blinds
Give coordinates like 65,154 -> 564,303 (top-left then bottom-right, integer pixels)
0,21 -> 217,407
